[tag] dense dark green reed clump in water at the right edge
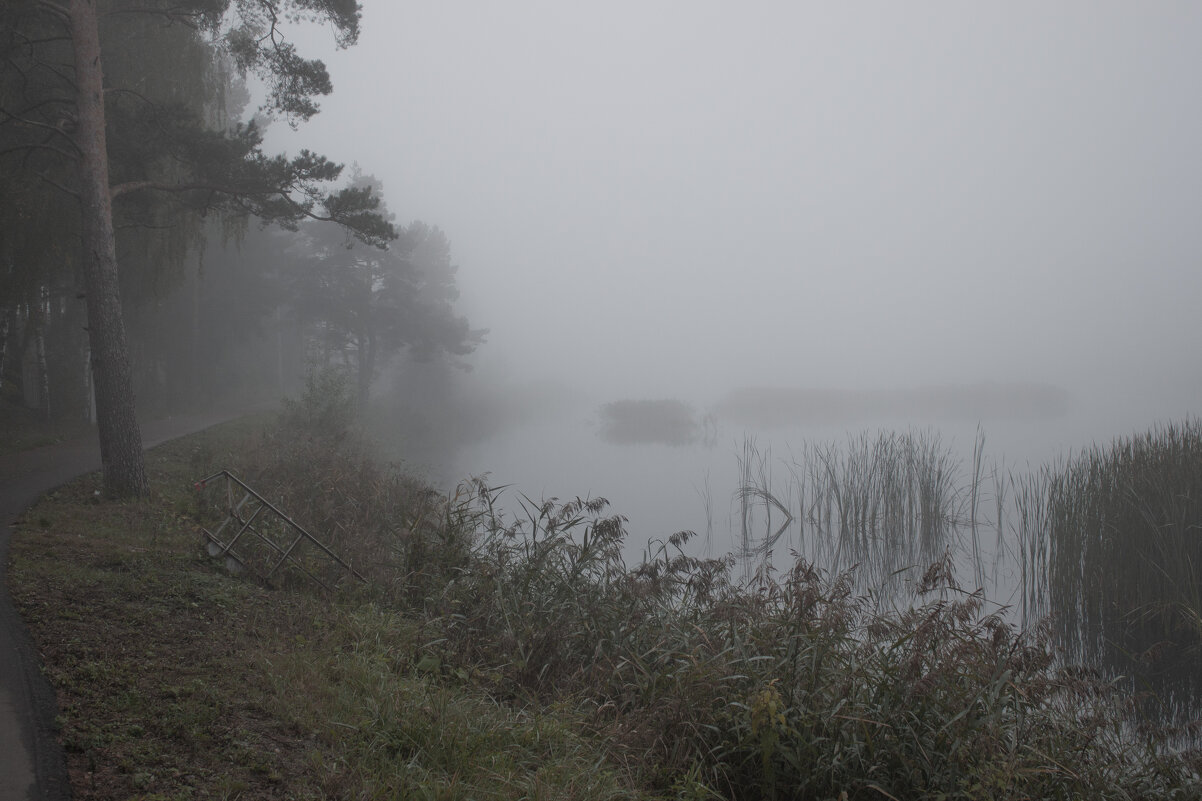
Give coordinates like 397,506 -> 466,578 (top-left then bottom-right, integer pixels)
1019,420 -> 1202,717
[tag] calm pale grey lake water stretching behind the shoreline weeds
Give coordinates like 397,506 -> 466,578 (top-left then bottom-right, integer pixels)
375,382 -> 1202,714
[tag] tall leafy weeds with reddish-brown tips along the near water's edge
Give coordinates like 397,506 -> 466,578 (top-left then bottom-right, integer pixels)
428,485 -> 1198,799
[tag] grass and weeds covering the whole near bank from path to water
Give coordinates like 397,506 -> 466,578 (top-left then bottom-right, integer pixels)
10,384 -> 1202,801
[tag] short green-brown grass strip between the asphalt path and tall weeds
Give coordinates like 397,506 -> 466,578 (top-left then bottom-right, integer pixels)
10,413 -> 630,799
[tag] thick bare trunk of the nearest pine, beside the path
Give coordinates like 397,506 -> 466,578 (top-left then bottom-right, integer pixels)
69,0 -> 148,497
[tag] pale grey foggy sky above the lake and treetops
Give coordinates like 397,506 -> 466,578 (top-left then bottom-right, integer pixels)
265,0 -> 1202,422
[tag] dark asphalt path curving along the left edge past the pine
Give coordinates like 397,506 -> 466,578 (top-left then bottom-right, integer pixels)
0,410 -> 268,801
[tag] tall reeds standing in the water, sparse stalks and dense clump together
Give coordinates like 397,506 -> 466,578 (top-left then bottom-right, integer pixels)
736,420 -> 1202,742
